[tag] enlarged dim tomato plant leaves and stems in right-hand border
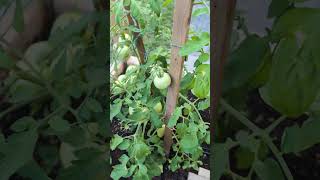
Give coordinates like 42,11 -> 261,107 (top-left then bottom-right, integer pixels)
212,0 -> 320,180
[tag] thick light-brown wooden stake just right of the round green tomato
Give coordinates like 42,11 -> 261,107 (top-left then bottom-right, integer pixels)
164,0 -> 192,155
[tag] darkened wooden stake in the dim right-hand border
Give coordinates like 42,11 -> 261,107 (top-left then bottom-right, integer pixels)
210,0 -> 236,143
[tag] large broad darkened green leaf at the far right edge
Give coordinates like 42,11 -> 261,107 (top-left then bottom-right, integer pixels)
262,36 -> 320,117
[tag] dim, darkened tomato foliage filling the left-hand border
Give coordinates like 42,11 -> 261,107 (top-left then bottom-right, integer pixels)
0,3 -> 110,180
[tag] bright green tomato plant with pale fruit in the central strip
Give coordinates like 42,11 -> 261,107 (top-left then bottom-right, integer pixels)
110,0 -> 210,180
